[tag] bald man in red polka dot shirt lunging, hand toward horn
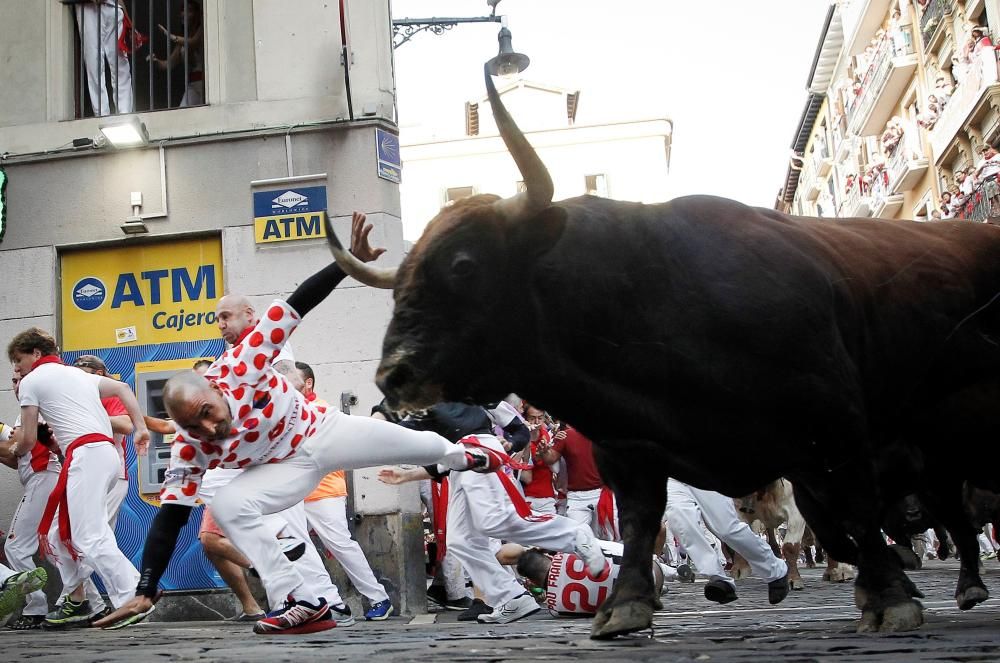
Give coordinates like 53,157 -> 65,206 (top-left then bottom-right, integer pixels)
98,213 -> 497,634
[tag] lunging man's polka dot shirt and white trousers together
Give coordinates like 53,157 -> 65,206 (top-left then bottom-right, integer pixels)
160,300 -> 467,605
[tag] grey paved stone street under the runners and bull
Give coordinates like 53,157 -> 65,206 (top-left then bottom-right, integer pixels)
0,561 -> 1000,663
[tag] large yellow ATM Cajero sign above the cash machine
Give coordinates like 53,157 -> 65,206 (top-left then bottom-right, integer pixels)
60,237 -> 223,350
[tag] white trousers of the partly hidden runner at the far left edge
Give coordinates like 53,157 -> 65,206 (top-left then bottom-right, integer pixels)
3,470 -> 59,616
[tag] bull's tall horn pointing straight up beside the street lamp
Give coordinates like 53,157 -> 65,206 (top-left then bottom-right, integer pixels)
483,60 -> 552,221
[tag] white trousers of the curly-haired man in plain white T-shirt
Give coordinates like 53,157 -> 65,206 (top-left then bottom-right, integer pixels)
49,443 -> 139,608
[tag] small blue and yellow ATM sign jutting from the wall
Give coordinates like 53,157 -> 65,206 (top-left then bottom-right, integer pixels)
253,186 -> 326,244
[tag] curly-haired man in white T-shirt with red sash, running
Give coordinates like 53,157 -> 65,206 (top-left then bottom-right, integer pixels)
7,327 -> 149,616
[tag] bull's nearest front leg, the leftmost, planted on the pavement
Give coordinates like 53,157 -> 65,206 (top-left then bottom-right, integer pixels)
590,441 -> 667,640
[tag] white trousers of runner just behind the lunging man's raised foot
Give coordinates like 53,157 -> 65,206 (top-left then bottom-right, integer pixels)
448,435 -> 583,608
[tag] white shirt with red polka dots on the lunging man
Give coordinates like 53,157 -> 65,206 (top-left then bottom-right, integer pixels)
160,299 -> 325,506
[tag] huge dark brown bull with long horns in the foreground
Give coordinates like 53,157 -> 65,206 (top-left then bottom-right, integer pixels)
329,65 -> 1000,638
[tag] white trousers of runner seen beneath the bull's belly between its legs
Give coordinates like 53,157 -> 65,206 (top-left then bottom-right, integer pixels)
667,479 -> 788,585
